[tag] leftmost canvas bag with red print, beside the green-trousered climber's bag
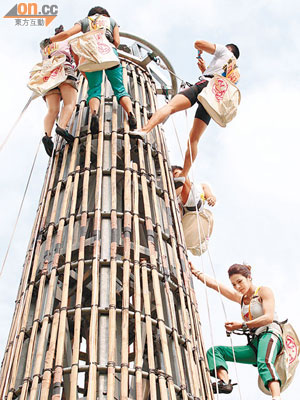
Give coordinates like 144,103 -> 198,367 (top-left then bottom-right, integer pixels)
27,54 -> 67,96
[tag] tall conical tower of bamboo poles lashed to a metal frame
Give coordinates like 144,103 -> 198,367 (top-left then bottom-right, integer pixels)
0,33 -> 213,400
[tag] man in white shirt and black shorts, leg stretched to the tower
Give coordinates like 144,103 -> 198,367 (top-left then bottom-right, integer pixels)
134,40 -> 240,166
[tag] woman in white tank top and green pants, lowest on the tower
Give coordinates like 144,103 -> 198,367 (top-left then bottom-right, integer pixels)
190,263 -> 283,400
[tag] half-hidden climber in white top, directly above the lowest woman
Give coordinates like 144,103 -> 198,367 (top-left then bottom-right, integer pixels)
172,165 -> 216,213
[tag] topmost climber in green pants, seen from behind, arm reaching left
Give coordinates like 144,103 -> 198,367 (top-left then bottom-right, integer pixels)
41,7 -> 138,136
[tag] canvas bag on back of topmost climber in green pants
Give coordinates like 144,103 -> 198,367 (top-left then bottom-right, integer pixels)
70,15 -> 120,72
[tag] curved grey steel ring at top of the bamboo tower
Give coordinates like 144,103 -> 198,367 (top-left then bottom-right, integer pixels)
118,32 -> 178,96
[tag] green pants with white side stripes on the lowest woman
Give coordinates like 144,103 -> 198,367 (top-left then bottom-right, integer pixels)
207,332 -> 282,389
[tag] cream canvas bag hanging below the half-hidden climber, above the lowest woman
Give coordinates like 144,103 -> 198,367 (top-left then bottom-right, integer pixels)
182,208 -> 214,256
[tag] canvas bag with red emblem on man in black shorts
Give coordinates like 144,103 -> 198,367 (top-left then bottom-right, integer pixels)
198,74 -> 241,128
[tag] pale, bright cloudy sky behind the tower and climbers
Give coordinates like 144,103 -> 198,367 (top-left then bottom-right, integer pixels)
0,0 -> 300,400
